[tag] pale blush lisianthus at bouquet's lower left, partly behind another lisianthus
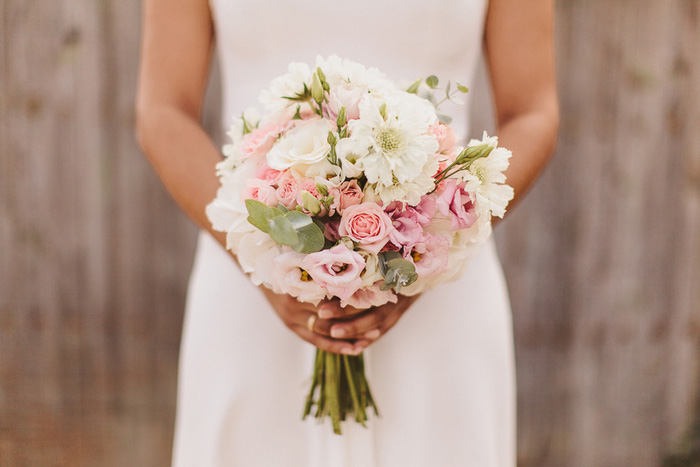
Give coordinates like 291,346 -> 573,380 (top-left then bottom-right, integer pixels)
271,251 -> 326,305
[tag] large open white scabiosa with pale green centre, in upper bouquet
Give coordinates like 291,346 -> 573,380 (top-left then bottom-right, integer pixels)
348,91 -> 439,186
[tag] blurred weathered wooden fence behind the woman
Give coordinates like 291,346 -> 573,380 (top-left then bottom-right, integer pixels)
0,0 -> 700,466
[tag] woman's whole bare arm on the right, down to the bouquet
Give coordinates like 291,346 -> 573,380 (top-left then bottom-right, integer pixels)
485,0 -> 559,216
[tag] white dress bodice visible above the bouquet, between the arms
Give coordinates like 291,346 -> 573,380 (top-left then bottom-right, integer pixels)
210,0 -> 488,135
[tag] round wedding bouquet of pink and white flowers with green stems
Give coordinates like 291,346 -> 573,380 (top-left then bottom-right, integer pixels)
207,56 -> 513,433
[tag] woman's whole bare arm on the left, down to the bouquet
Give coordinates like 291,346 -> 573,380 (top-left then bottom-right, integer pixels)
136,0 -> 225,245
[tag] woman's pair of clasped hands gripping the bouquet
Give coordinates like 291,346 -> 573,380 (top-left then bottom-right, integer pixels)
260,286 -> 417,355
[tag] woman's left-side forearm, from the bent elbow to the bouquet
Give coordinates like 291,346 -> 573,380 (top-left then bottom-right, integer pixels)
137,106 -> 226,245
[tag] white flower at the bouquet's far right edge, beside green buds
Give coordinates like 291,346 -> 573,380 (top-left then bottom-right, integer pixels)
467,132 -> 514,217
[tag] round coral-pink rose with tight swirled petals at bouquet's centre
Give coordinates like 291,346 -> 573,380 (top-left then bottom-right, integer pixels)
338,203 -> 394,253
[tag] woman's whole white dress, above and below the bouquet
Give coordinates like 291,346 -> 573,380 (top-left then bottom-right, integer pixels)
173,0 -> 515,467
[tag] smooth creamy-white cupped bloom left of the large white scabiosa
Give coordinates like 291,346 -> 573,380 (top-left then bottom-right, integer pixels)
267,118 -> 332,177
